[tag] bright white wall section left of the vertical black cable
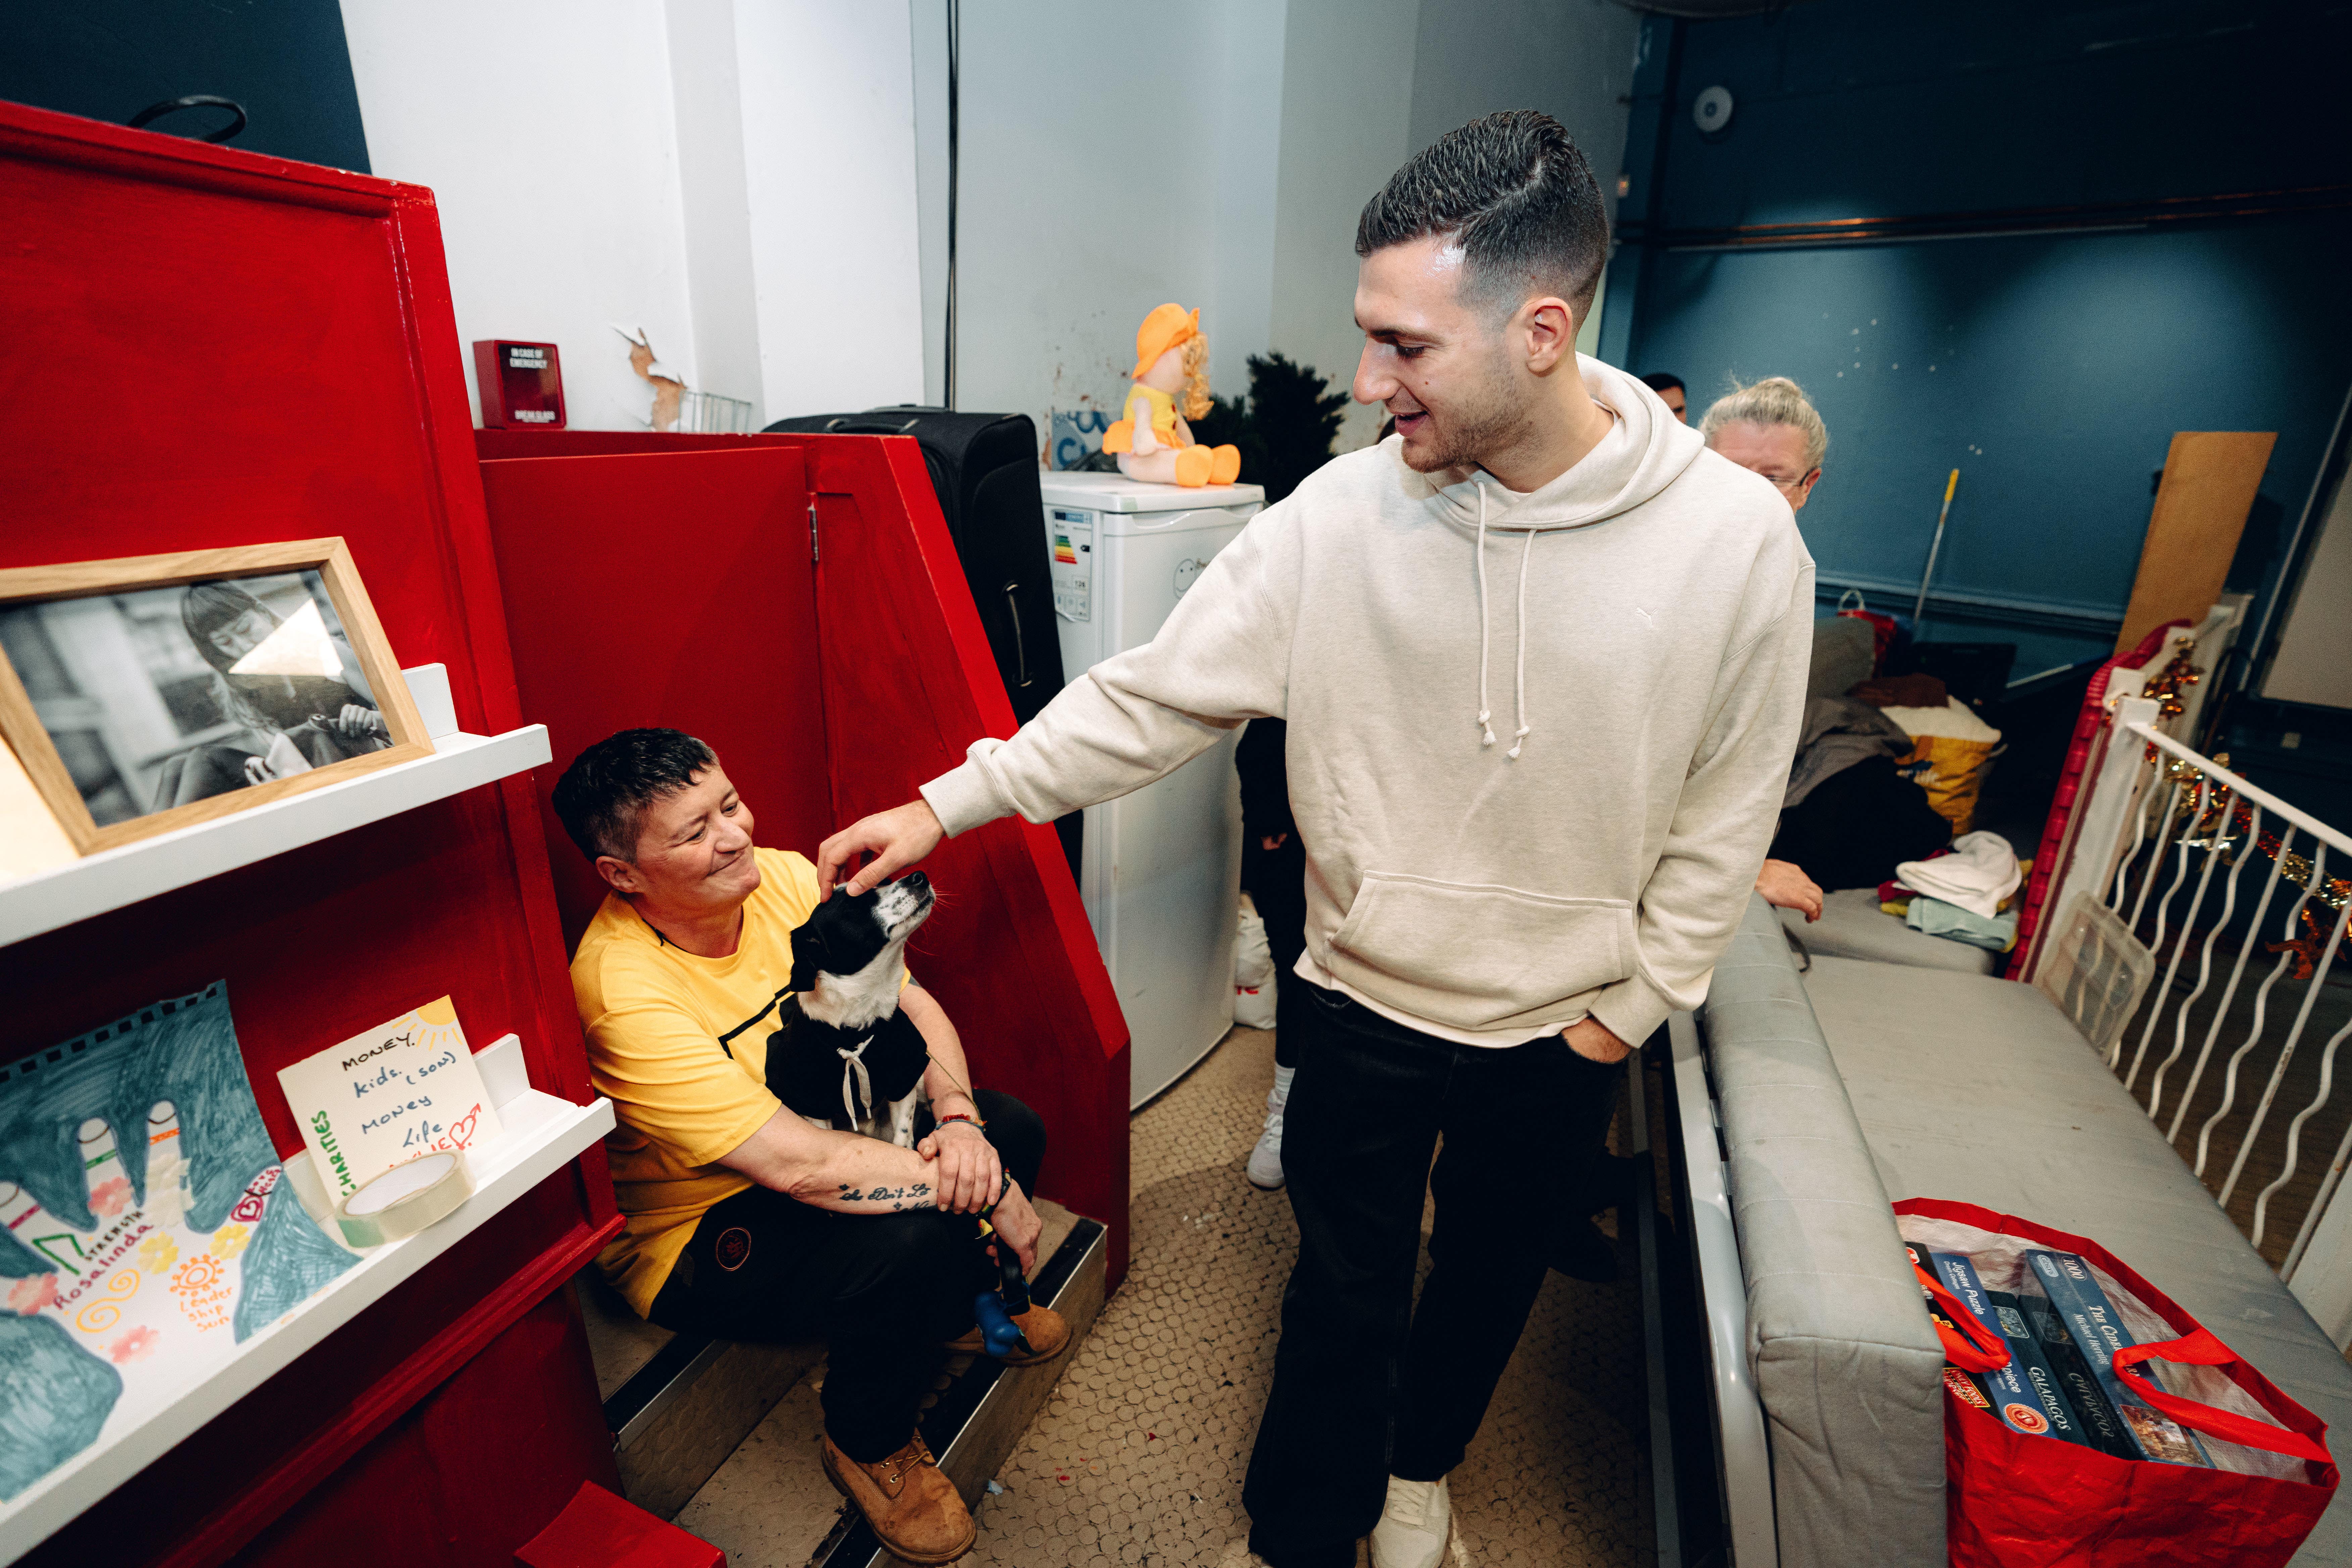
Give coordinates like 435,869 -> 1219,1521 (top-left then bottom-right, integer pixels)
343,0 -> 922,430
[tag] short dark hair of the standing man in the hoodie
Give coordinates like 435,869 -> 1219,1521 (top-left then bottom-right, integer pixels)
1355,108 -> 1609,325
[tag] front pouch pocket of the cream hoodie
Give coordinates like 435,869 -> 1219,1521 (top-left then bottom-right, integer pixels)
1327,872 -> 1635,1030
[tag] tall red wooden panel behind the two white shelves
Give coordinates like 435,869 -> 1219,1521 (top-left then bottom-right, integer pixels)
0,103 -> 614,1563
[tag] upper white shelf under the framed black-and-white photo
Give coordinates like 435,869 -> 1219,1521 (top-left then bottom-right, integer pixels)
0,682 -> 550,947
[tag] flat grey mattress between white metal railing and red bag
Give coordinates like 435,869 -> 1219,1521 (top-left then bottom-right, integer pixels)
1776,957 -> 2352,1563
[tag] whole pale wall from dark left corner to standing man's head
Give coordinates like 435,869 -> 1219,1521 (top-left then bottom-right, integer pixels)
343,0 -> 1635,447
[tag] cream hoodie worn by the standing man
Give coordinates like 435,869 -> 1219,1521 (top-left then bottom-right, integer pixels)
922,360 -> 1813,1046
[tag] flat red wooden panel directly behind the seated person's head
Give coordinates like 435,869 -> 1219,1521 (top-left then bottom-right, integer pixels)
482,446 -> 833,947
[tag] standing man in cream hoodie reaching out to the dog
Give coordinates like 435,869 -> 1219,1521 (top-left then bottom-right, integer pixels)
819,110 -> 1813,1568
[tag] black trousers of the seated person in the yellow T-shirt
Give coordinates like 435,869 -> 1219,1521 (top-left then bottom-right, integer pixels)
649,1088 -> 1044,1465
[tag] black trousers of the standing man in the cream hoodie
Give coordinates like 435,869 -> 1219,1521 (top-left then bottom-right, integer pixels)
1242,980 -> 1623,1568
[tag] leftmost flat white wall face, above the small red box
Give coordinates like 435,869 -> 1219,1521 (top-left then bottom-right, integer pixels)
343,0 -> 696,430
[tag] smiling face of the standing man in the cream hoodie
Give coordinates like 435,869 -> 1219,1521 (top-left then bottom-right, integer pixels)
1353,235 -> 1573,473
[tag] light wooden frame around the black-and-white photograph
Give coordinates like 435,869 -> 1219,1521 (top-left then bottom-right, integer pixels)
0,538 -> 433,856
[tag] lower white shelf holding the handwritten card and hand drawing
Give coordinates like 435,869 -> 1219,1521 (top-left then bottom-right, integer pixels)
0,1034 -> 614,1566
